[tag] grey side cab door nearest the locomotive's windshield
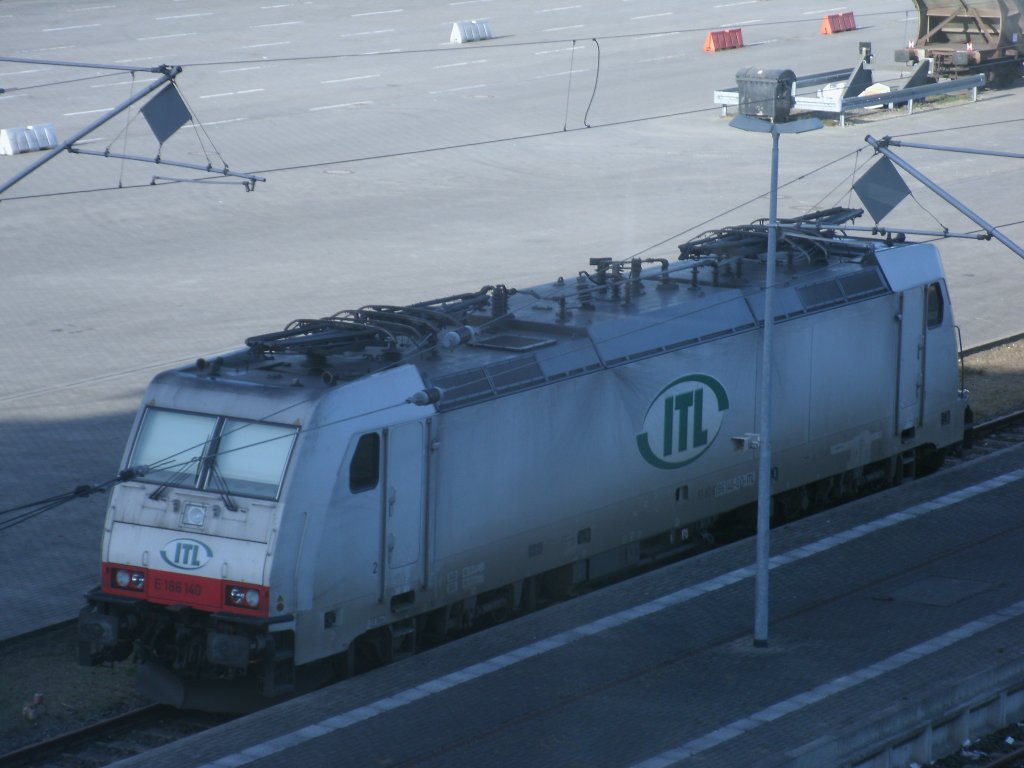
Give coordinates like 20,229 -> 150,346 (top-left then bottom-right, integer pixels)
381,422 -> 427,600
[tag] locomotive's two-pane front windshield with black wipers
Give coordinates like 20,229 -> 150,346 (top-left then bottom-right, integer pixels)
129,408 -> 298,499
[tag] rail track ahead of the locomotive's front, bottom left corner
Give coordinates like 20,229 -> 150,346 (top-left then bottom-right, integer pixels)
0,705 -> 231,768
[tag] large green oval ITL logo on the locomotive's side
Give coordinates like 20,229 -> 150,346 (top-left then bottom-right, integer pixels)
637,374 -> 729,469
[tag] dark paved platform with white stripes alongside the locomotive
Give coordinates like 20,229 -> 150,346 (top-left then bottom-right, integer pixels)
105,447 -> 1024,768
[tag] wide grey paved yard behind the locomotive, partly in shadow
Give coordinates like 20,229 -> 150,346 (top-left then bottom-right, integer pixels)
0,0 -> 1024,637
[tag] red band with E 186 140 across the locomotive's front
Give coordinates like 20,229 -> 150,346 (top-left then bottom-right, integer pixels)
102,563 -> 270,616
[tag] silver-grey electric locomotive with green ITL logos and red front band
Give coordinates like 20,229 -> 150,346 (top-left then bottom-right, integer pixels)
80,209 -> 967,709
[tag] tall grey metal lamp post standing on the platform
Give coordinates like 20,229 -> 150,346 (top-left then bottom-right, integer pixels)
729,97 -> 821,648
